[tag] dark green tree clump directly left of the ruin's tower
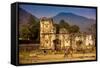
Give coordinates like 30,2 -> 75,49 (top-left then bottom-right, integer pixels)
19,15 -> 40,42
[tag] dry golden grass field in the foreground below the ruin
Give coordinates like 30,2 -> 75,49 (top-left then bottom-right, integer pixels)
19,51 -> 96,64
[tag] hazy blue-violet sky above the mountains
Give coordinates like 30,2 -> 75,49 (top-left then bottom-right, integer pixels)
20,4 -> 96,19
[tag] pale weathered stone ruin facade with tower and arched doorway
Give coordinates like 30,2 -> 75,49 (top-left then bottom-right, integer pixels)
40,17 -> 95,49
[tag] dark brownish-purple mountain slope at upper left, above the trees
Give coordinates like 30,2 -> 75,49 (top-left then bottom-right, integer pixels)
19,8 -> 39,25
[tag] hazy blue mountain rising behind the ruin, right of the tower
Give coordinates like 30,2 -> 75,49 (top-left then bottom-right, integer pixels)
53,12 -> 96,32
